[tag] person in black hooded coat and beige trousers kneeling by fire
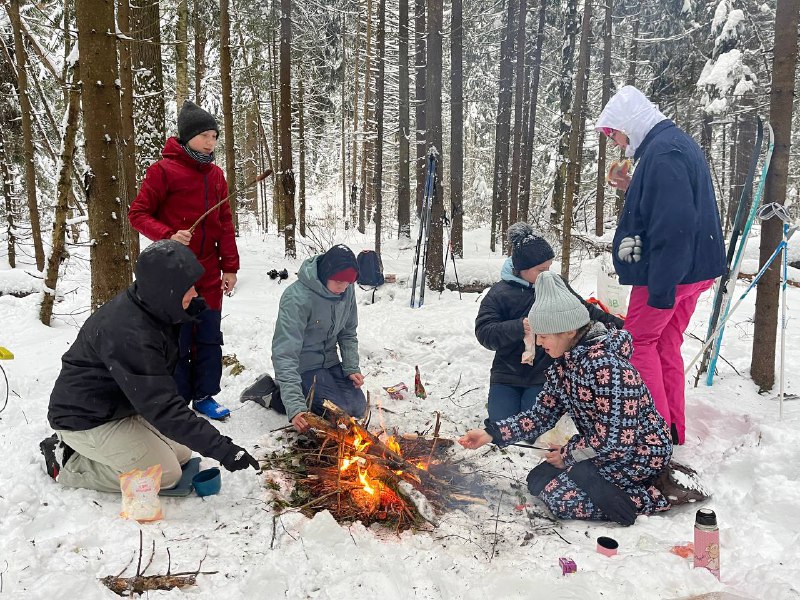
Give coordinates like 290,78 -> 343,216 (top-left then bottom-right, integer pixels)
42,240 -> 258,492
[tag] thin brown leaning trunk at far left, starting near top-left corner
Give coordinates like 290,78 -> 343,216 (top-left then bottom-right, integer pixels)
6,0 -> 44,271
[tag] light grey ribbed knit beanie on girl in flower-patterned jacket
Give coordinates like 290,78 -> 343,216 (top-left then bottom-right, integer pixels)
528,271 -> 589,333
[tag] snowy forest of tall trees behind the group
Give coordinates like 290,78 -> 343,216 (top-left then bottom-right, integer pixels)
0,0 -> 800,389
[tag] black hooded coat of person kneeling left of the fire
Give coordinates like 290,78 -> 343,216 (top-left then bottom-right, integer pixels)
47,243 -> 234,460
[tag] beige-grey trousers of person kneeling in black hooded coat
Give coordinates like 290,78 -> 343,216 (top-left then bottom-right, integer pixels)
56,415 -> 192,493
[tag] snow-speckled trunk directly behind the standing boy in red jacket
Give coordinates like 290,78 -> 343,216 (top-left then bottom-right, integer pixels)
130,0 -> 167,181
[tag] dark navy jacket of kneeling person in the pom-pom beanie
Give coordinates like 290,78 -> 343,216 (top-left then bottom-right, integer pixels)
475,265 -> 623,387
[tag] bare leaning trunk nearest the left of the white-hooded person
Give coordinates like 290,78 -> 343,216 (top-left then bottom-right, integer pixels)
561,0 -> 592,279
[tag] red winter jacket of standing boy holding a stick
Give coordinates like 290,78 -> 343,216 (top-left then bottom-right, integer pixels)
128,137 -> 239,310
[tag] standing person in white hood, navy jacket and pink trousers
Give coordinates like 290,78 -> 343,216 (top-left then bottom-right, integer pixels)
595,85 -> 726,444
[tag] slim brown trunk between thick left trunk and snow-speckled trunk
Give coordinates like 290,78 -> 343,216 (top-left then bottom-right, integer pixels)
117,2 -> 139,264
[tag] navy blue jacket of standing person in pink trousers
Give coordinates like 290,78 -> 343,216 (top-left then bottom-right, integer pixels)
613,119 -> 725,309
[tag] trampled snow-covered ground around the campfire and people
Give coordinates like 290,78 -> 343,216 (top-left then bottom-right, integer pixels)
0,221 -> 800,600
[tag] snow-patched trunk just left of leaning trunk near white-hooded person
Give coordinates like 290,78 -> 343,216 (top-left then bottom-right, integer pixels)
550,0 -> 578,229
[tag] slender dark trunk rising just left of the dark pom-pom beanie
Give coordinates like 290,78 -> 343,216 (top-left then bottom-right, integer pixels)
489,0 -> 517,252
